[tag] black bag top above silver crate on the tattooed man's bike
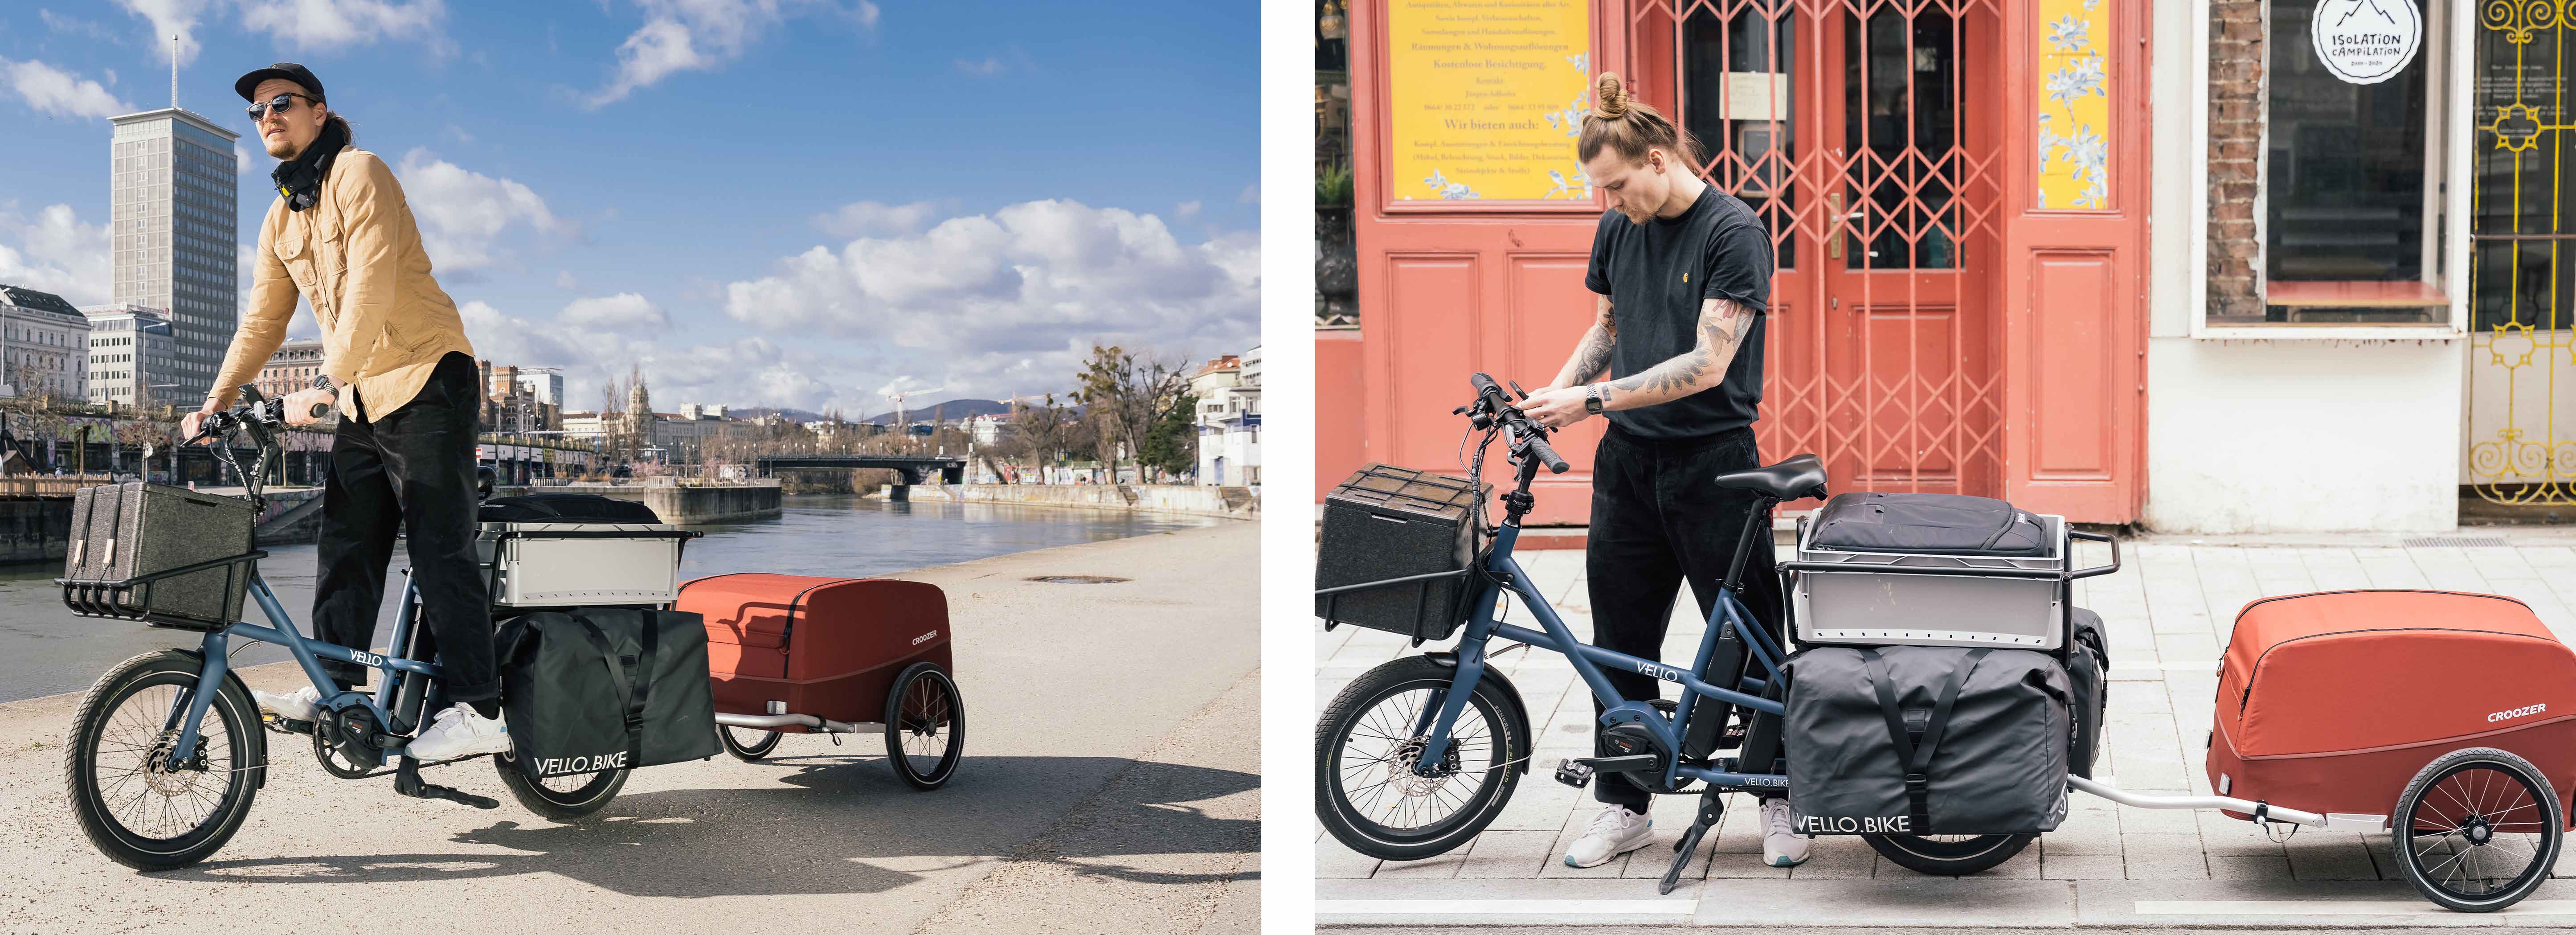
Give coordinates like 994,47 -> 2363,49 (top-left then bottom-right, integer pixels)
1814,492 -> 2050,556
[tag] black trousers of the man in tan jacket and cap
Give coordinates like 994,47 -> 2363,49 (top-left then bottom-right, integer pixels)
314,353 -> 500,703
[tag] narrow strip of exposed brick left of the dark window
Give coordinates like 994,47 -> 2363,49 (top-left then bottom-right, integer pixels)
2208,0 -> 2267,322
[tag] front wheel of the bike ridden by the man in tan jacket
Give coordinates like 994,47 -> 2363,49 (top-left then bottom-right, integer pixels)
62,649 -> 268,871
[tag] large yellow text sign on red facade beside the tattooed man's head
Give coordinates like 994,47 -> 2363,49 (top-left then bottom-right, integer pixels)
1386,0 -> 1592,201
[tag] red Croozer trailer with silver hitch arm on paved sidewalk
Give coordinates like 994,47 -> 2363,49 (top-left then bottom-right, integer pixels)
2069,590 -> 2576,912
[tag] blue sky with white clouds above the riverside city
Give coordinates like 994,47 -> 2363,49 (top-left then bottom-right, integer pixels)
0,0 -> 1259,412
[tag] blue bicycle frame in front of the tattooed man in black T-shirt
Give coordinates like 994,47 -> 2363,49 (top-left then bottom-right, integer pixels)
1414,461 -> 1788,788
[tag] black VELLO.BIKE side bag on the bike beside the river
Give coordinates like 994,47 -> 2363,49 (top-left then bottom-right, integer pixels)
497,608 -> 721,778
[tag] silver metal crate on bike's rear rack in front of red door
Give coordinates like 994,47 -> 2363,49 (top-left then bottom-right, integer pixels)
1788,515 -> 2074,649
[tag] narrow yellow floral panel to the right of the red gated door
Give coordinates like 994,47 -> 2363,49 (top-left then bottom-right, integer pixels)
2038,0 -> 2110,211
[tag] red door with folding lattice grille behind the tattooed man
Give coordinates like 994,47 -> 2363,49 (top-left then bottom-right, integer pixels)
1625,0 -> 2004,495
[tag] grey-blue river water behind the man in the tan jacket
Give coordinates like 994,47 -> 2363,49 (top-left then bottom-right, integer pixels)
0,495 -> 1231,703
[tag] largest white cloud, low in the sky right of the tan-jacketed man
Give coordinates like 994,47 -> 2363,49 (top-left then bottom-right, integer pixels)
724,201 -> 1259,394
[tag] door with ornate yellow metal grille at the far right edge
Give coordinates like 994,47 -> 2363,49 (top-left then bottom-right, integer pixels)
2465,0 -> 2576,505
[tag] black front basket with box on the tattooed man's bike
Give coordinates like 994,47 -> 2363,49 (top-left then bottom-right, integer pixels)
1314,463 -> 1484,641
